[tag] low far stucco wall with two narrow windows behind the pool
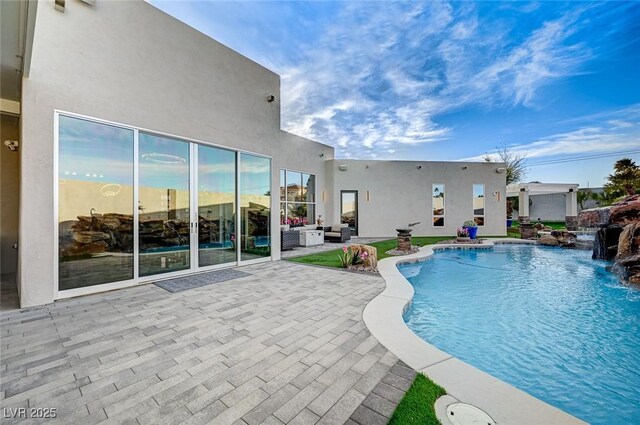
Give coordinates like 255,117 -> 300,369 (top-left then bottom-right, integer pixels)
327,159 -> 506,237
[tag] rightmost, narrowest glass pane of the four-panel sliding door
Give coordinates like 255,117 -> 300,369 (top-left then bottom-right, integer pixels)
237,153 -> 270,260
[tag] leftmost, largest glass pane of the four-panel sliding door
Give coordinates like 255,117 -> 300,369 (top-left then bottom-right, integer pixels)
58,115 -> 133,290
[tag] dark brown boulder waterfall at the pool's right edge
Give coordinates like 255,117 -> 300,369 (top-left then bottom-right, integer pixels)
578,195 -> 640,284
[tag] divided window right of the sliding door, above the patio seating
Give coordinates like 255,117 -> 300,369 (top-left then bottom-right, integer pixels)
280,170 -> 316,226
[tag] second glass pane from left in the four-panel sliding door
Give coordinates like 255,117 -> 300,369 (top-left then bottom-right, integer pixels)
138,132 -> 190,276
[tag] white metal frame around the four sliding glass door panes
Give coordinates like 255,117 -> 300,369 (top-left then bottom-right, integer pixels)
52,109 -> 272,300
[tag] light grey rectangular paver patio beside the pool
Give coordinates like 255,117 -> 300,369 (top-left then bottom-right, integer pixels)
0,261 -> 413,425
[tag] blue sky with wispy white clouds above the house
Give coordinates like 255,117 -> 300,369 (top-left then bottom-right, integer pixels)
152,0 -> 640,187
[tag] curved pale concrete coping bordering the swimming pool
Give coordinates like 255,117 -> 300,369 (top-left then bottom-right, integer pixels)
362,238 -> 586,425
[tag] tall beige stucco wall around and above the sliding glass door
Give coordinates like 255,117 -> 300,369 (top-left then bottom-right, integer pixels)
20,0 -> 333,307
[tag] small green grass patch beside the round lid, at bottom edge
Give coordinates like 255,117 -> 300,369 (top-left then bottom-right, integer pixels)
389,373 -> 447,425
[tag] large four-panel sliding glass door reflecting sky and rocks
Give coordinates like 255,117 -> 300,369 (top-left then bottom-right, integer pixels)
56,114 -> 271,292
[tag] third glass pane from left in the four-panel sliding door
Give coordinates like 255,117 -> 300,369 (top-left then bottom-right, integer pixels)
198,145 -> 236,267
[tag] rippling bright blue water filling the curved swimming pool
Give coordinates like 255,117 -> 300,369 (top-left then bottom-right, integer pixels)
400,245 -> 640,424
